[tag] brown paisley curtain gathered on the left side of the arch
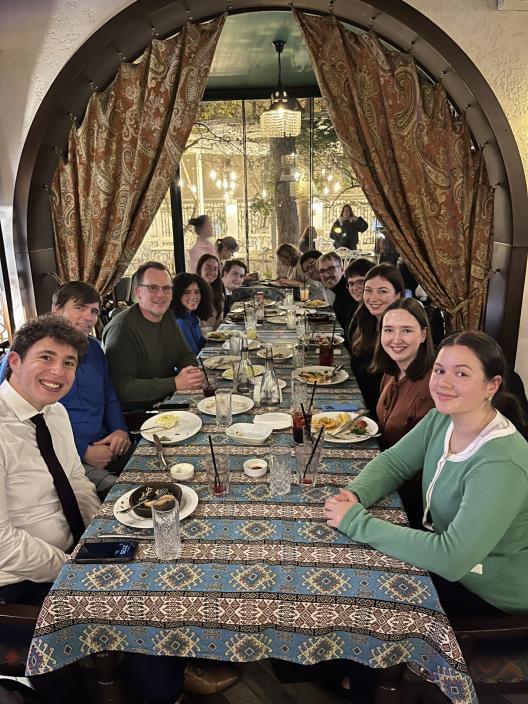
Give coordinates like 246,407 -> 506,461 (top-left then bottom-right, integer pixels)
51,15 -> 225,292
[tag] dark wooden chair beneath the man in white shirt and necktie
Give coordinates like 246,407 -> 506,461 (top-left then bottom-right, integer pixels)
0,604 -> 125,704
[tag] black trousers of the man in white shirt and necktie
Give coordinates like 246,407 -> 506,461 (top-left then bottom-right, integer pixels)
0,580 -> 186,704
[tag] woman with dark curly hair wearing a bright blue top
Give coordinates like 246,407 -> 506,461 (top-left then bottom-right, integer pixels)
172,274 -> 213,354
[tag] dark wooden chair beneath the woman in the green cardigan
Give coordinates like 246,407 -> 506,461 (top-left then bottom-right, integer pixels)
405,615 -> 528,704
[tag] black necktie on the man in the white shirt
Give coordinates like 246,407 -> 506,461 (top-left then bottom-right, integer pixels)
31,413 -> 85,545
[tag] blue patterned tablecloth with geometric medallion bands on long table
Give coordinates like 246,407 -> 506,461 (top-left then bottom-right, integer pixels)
27,314 -> 477,703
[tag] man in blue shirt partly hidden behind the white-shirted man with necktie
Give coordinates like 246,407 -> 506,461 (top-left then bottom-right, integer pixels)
0,281 -> 130,498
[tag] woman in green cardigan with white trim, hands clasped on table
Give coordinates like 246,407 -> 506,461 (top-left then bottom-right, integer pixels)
324,332 -> 528,616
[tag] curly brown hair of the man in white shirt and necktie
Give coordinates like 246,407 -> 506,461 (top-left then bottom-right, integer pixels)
6,313 -> 88,379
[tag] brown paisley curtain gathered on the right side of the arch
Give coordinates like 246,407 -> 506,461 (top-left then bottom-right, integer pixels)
294,10 -> 493,330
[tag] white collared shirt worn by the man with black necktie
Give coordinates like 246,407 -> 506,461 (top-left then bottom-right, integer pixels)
0,381 -> 100,586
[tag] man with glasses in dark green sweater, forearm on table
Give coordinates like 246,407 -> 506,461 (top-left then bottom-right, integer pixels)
103,262 -> 203,410
